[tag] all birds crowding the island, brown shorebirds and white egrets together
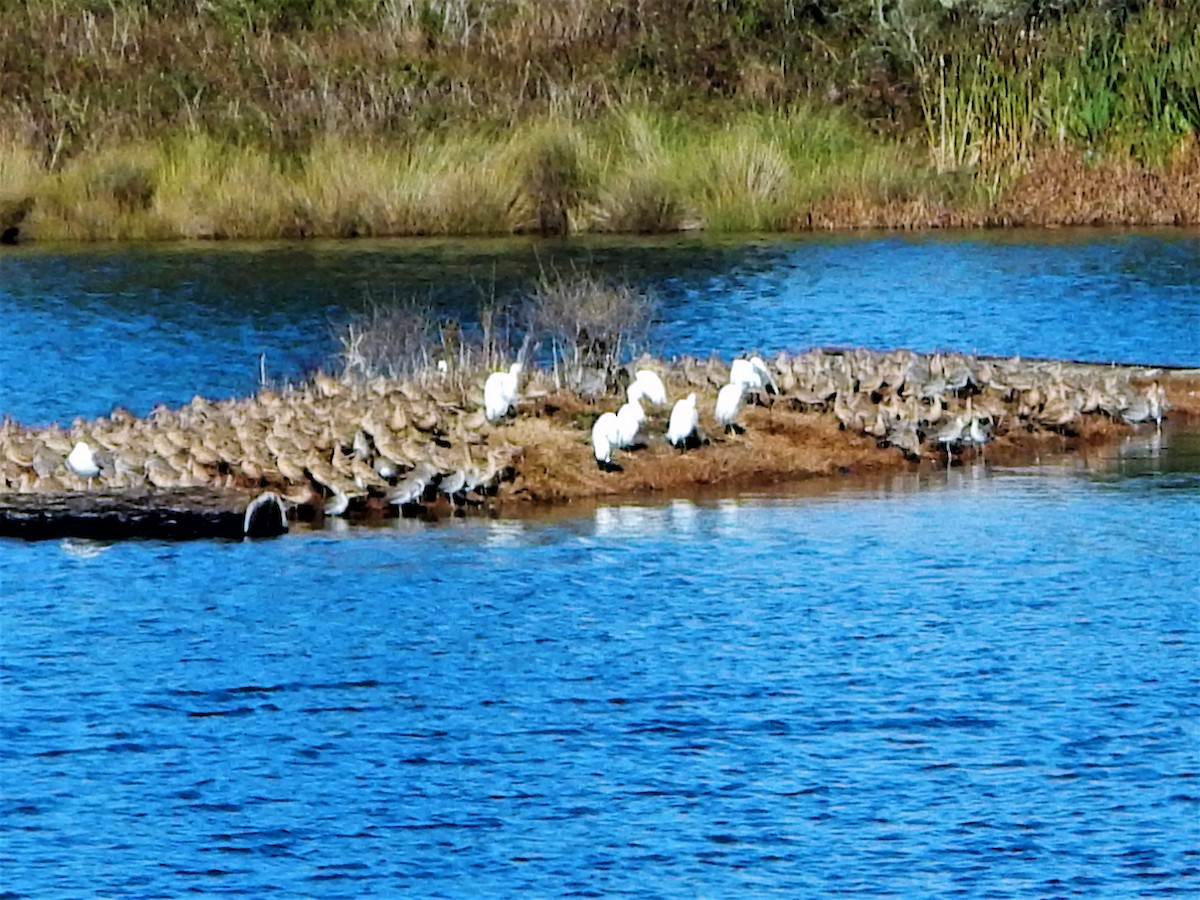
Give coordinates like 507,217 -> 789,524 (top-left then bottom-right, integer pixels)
0,349 -> 1168,516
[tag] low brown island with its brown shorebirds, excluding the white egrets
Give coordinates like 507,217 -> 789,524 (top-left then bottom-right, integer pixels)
0,348 -> 1200,535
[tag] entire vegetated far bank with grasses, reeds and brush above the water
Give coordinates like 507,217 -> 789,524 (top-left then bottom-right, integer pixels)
0,0 -> 1200,239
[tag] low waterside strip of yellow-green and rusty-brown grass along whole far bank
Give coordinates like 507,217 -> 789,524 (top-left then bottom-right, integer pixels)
0,114 -> 1200,240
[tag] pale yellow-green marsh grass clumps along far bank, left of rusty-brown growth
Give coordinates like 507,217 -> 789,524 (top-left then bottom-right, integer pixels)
0,106 -> 940,240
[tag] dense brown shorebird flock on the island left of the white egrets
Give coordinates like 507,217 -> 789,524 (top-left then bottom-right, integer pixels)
0,374 -> 520,515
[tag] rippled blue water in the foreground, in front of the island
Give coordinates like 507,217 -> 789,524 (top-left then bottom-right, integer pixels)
0,434 -> 1200,898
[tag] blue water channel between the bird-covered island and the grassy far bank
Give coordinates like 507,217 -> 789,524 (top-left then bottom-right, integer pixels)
0,229 -> 1200,424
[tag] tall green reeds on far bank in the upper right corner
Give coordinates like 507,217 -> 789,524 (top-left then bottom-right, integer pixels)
916,2 -> 1200,173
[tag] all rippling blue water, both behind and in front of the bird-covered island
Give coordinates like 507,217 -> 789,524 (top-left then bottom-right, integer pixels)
0,235 -> 1200,899
